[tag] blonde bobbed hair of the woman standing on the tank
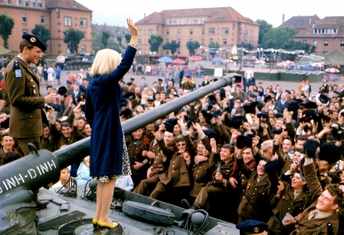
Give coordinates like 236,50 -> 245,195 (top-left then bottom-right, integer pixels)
90,49 -> 122,76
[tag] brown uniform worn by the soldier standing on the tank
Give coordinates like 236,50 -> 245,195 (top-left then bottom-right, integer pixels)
5,57 -> 44,155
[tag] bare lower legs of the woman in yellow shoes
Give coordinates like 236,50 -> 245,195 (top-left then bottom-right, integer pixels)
96,179 -> 115,223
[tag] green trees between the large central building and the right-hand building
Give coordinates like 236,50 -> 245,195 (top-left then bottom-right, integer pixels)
262,27 -> 311,51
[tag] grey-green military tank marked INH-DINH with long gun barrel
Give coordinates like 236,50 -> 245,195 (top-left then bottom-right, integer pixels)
0,75 -> 239,235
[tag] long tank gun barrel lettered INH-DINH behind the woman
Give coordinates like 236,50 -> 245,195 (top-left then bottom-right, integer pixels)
0,76 -> 232,200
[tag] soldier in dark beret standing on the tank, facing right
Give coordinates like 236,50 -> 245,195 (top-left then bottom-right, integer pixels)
5,33 -> 56,155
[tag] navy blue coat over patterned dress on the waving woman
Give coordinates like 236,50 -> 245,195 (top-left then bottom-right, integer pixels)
86,46 -> 136,177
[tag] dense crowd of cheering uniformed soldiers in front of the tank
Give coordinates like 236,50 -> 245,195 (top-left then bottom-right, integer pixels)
0,63 -> 344,234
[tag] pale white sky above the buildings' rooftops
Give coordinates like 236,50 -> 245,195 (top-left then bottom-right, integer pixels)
77,0 -> 344,27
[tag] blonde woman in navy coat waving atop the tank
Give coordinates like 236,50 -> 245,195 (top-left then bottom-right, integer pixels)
86,19 -> 138,229
